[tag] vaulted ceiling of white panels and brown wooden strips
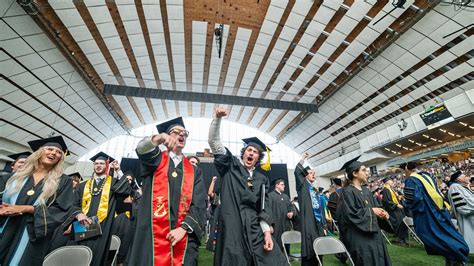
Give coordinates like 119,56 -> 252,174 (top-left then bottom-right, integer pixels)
0,0 -> 473,163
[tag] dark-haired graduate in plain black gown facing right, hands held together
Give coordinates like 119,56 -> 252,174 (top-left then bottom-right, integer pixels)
341,157 -> 391,266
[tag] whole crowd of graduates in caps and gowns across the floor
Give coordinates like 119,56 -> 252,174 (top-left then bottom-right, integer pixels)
0,108 -> 474,265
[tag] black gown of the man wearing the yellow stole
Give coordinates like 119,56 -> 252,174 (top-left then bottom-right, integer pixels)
68,176 -> 131,266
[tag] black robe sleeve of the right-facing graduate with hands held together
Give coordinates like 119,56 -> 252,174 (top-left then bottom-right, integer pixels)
342,189 -> 378,233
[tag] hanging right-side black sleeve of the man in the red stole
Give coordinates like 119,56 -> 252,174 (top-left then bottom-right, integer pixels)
183,167 -> 207,239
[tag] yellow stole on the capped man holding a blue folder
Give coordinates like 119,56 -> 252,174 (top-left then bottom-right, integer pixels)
81,176 -> 112,222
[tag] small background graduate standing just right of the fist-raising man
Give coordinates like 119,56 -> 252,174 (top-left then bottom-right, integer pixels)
268,179 -> 296,253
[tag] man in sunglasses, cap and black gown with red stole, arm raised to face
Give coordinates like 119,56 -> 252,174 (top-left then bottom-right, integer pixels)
128,117 -> 206,265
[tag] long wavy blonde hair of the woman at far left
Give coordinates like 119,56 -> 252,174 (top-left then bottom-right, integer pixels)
5,146 -> 65,205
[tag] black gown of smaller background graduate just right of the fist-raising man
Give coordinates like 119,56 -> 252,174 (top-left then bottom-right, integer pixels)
268,191 -> 296,248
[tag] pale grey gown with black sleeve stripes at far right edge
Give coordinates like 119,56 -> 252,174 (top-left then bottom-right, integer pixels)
448,183 -> 474,254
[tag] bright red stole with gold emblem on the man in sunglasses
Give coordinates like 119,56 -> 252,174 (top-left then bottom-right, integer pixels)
152,152 -> 194,266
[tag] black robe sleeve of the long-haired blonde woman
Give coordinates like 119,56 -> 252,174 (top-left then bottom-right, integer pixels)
26,175 -> 73,242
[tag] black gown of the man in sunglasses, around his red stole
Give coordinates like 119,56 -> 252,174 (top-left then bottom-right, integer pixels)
127,147 -> 207,265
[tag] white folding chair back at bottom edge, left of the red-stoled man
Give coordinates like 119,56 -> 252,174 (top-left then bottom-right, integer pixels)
43,246 -> 92,266
